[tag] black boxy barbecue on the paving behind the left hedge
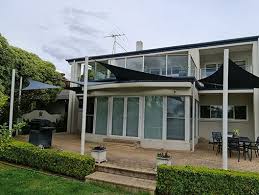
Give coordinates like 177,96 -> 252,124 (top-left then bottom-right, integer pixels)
29,119 -> 55,148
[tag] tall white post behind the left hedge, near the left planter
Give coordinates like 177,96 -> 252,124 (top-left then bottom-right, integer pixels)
81,57 -> 88,155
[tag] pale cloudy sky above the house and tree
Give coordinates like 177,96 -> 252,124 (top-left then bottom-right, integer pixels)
0,0 -> 259,78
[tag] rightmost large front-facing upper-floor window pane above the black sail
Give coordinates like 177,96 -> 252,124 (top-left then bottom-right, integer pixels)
167,55 -> 188,76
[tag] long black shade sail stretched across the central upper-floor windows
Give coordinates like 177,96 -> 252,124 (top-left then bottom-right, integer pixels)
98,62 -> 195,83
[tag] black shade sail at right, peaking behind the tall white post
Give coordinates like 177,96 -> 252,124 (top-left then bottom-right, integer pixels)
199,60 -> 259,90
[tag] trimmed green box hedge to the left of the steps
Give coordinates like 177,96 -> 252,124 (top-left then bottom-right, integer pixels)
0,141 -> 95,179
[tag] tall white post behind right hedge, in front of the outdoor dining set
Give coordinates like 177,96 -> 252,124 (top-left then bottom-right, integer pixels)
222,49 -> 229,170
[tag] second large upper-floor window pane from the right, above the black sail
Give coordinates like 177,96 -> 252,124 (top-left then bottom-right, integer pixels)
144,55 -> 166,75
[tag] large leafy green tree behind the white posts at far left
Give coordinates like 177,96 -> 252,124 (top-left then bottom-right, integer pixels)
0,34 -> 64,123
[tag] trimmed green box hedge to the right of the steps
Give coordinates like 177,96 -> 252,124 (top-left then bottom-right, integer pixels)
157,165 -> 259,195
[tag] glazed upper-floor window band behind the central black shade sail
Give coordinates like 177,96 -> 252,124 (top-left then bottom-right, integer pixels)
85,52 -> 199,80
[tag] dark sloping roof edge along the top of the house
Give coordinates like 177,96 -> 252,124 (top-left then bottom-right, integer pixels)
66,36 -> 259,62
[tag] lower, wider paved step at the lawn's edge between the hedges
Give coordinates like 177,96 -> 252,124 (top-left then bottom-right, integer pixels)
85,171 -> 156,194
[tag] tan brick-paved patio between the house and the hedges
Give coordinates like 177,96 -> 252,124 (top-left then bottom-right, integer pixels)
17,133 -> 259,172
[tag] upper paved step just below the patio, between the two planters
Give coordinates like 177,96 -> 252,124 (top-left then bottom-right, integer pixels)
95,163 -> 156,180
